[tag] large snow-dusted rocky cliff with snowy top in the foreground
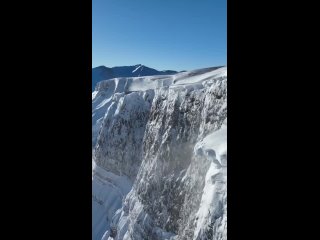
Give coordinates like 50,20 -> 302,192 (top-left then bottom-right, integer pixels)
92,67 -> 227,240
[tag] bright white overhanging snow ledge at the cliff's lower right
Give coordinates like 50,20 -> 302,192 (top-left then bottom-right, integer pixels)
194,122 -> 227,239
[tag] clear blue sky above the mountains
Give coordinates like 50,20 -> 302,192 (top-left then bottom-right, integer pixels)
92,0 -> 227,71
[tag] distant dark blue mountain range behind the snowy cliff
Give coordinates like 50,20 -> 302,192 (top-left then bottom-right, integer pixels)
92,64 -> 178,91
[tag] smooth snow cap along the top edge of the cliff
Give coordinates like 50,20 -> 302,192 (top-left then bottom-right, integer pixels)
92,67 -> 227,147
